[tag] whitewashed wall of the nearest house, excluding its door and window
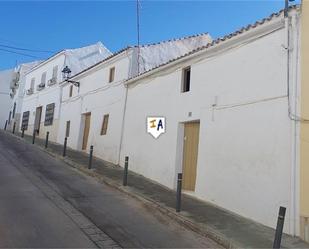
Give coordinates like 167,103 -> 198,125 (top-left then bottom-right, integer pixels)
121,23 -> 293,232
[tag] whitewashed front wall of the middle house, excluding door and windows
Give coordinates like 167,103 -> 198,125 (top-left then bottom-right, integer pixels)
58,52 -> 131,164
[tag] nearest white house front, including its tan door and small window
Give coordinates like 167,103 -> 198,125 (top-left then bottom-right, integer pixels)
120,8 -> 300,235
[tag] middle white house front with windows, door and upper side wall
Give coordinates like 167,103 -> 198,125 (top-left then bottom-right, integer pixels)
58,33 -> 211,164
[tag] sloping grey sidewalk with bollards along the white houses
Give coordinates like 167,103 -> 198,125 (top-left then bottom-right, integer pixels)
9,131 -> 309,248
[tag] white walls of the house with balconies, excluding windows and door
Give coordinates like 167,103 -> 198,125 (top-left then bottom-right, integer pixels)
19,42 -> 111,142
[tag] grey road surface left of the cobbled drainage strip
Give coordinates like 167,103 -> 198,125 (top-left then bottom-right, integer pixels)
0,138 -> 96,248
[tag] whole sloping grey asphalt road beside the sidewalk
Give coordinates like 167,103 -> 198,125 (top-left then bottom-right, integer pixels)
0,131 -> 219,248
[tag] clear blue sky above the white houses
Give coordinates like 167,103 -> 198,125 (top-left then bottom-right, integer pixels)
0,0 -> 300,70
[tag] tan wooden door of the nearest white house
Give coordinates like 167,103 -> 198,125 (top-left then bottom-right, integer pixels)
182,122 -> 200,191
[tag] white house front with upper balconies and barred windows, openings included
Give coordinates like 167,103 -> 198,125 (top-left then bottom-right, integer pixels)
20,43 -> 111,142
